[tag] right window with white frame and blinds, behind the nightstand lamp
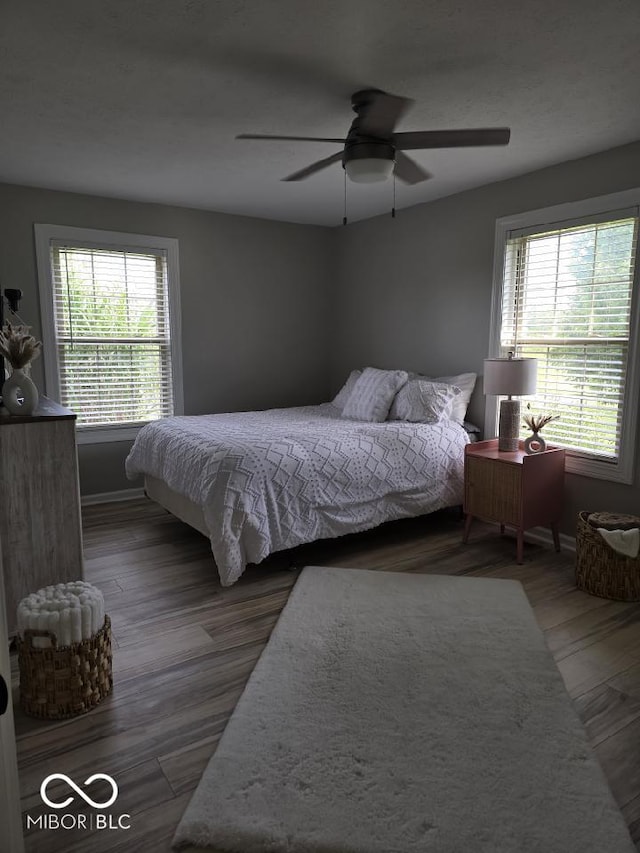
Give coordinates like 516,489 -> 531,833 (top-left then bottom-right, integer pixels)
487,191 -> 640,482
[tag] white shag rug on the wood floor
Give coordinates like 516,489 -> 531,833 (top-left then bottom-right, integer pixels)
174,567 -> 635,853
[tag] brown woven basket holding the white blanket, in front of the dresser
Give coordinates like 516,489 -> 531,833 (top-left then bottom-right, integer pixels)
18,616 -> 113,720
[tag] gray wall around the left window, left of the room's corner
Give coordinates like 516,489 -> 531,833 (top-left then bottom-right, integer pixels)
0,185 -> 335,494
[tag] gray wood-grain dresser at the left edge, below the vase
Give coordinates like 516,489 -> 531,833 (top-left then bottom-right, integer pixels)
0,397 -> 84,637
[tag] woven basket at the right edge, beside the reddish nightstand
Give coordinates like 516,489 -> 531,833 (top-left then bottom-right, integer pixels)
576,512 -> 640,601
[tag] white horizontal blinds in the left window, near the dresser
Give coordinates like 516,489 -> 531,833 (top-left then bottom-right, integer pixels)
50,240 -> 173,428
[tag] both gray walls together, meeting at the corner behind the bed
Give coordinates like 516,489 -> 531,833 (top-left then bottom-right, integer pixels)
5,138 -> 640,532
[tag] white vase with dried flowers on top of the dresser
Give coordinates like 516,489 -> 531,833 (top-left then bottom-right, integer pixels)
0,323 -> 42,415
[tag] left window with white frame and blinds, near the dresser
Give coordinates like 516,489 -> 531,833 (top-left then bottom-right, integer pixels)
35,225 -> 182,442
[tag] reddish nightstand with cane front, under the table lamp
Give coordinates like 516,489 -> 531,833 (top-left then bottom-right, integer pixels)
462,439 -> 564,563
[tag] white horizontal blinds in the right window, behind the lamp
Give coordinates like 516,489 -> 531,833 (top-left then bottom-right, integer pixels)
500,216 -> 638,461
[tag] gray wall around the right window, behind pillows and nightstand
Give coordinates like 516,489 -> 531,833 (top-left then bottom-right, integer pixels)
331,143 -> 640,532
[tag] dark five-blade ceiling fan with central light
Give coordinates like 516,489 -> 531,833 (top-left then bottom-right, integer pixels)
236,89 -> 511,184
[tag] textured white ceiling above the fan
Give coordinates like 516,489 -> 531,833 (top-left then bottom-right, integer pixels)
0,0 -> 640,225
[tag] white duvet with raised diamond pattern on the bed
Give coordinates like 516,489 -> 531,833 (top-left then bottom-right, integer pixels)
126,403 -> 469,586
